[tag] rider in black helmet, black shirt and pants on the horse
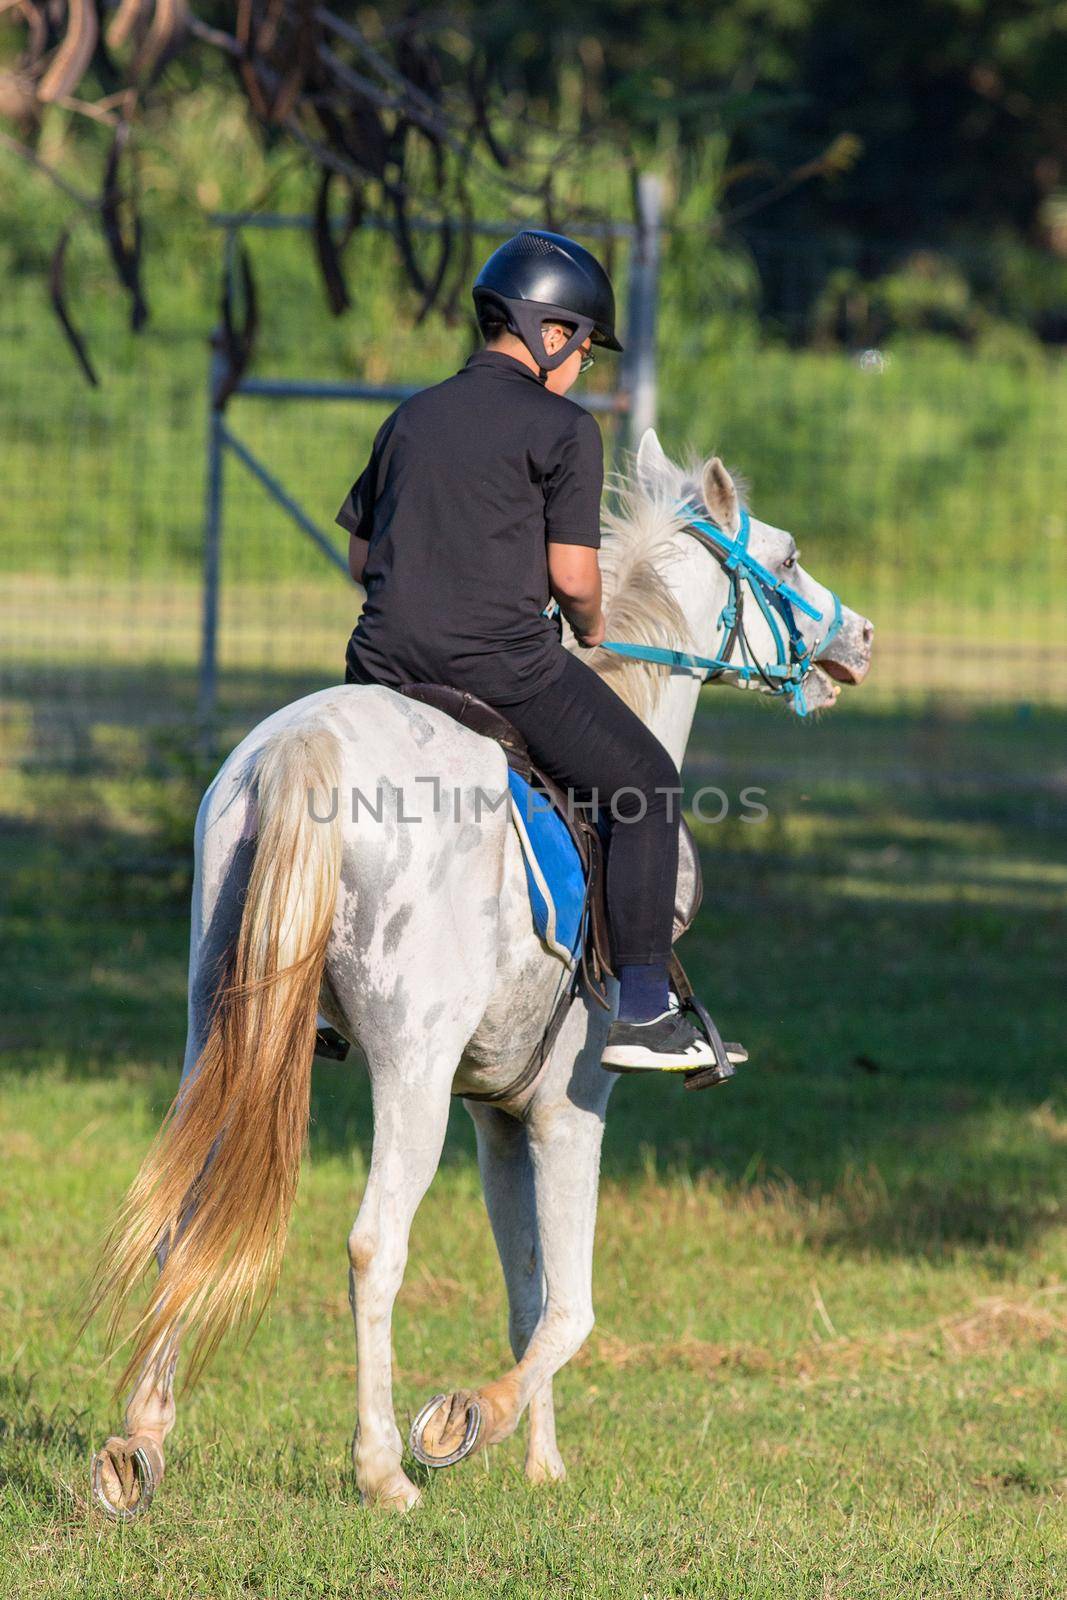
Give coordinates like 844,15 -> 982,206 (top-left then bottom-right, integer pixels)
338,229 -> 726,1070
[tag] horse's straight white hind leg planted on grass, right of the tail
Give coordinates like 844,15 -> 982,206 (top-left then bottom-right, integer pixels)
349,1045 -> 462,1510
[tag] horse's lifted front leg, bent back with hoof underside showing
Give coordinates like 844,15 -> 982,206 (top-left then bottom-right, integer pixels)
411,1066 -> 611,1466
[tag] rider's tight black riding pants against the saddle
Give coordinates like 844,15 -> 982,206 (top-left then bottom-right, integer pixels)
501,654 -> 681,966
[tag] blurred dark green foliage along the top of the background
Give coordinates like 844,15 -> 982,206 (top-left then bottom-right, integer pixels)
0,0 -> 1067,346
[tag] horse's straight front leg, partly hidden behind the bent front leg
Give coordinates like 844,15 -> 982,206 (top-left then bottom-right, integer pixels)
466,1101 -> 566,1483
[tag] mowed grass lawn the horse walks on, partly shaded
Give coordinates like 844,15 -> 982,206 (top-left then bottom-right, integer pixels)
0,693 -> 1067,1600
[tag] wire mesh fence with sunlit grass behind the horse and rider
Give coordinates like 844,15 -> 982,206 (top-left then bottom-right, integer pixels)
0,217 -> 1067,780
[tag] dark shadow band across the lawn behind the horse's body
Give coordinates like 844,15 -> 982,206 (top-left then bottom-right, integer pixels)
0,704 -> 1067,1256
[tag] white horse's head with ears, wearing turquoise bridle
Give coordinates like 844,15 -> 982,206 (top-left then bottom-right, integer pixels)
637,429 -> 875,710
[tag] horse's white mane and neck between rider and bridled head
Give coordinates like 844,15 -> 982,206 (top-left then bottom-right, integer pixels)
573,434 -> 713,717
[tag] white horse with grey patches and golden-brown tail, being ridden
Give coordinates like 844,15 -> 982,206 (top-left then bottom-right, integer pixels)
93,432 -> 873,1517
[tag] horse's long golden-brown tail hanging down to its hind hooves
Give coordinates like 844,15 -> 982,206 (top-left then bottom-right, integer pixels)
88,726 -> 341,1387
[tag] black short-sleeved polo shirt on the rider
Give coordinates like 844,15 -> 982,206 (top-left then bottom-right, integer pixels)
338,350 -> 603,704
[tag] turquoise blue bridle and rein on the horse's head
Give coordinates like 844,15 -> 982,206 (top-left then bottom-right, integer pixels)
600,502 -> 841,717
